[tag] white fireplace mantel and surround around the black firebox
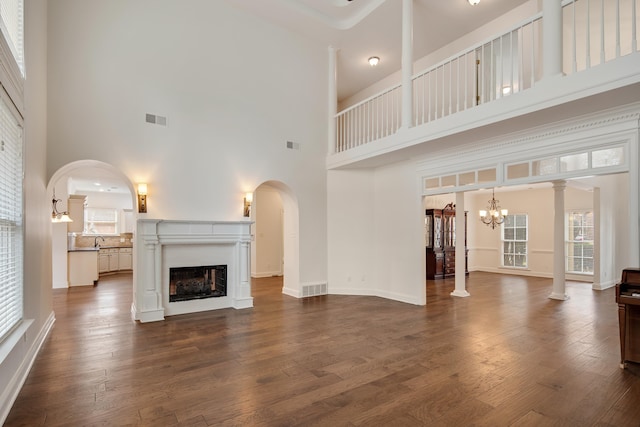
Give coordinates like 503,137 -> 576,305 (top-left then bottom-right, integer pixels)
131,219 -> 253,322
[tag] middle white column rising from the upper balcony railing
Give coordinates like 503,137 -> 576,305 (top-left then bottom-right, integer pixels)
402,0 -> 413,129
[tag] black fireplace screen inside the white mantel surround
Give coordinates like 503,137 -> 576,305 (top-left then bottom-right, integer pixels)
169,265 -> 227,302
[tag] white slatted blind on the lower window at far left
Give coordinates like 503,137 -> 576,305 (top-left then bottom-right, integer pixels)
0,93 -> 23,341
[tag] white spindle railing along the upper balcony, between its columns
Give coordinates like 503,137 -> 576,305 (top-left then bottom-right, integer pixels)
335,0 -> 640,153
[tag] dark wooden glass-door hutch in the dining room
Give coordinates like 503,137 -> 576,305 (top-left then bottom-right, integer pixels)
424,203 -> 469,279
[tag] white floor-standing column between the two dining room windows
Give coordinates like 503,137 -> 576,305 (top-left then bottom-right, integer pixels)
549,181 -> 569,300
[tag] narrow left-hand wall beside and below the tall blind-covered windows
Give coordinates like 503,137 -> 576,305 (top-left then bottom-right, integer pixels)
0,0 -> 54,424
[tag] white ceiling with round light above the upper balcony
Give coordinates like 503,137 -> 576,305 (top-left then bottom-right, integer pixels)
227,0 -> 528,100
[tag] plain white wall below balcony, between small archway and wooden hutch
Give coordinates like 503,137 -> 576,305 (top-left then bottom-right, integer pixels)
328,162 -> 426,304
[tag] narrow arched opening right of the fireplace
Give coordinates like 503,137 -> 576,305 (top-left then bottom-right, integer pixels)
251,181 -> 300,297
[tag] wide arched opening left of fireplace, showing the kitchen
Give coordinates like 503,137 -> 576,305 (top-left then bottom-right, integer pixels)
47,160 -> 136,288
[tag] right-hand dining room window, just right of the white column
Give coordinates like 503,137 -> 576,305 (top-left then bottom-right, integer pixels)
566,211 -> 593,274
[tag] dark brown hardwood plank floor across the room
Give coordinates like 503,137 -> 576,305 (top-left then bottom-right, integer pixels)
6,272 -> 640,427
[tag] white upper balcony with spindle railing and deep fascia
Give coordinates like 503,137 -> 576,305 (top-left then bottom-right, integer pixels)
327,0 -> 640,169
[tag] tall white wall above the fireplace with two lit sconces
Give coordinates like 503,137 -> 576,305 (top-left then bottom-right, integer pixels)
47,0 -> 327,290
